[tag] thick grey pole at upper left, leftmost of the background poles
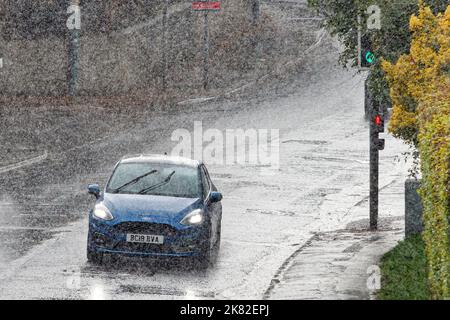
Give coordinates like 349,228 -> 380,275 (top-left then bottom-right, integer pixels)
66,0 -> 81,97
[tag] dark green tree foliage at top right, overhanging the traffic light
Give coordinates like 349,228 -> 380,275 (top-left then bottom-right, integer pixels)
308,0 -> 448,105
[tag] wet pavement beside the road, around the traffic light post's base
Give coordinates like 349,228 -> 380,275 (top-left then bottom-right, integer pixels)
264,179 -> 404,300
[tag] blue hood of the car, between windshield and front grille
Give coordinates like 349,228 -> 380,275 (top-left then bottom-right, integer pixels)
102,193 -> 202,224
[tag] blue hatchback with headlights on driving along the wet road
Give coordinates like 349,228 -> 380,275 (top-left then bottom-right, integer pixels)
87,155 -> 222,268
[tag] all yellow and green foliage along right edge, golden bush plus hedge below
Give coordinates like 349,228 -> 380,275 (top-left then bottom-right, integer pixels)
382,1 -> 450,299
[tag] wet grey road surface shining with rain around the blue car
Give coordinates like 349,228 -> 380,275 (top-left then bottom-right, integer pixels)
0,1 -> 412,299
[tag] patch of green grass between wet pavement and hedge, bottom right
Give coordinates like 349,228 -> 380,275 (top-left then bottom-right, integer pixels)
378,235 -> 431,300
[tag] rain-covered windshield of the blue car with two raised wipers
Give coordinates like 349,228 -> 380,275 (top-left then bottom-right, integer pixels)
106,162 -> 201,198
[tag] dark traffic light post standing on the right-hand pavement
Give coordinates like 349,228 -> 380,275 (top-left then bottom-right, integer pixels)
369,102 -> 379,231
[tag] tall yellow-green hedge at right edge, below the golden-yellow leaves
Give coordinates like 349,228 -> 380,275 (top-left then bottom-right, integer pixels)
419,112 -> 450,299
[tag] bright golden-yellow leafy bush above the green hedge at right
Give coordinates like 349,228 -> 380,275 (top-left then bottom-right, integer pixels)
382,4 -> 450,142
